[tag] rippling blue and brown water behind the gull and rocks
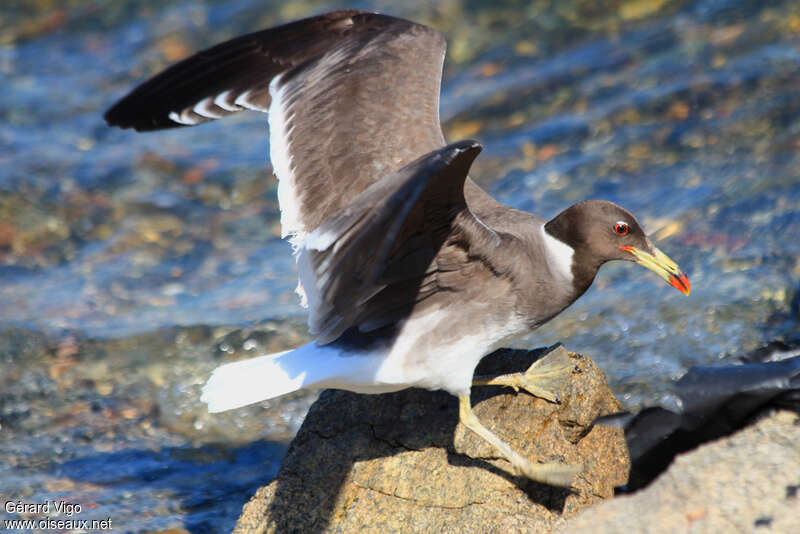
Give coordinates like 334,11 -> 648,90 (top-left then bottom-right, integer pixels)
0,0 -> 800,532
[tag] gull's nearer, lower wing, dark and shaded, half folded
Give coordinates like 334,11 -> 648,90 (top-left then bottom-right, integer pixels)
298,141 -> 505,344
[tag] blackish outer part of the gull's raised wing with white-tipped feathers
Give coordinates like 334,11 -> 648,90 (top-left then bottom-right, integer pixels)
105,10 -> 368,132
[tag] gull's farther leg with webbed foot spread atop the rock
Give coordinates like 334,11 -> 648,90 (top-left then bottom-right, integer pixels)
472,345 -> 575,403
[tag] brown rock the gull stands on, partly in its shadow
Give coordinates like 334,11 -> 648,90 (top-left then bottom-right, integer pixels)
235,348 -> 629,534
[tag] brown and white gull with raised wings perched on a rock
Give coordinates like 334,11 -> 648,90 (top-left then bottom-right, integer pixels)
105,10 -> 690,486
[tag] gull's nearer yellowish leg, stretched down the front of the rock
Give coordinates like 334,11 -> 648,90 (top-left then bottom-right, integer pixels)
458,395 -> 581,488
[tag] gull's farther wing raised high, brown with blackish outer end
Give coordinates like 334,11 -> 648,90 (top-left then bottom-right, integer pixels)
105,10 -> 445,244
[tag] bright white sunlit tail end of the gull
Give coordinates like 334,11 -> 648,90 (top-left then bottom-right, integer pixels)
200,350 -> 306,413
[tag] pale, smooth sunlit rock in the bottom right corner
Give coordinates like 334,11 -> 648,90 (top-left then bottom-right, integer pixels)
559,411 -> 800,534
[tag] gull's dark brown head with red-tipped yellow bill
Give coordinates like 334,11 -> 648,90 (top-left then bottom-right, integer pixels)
545,200 -> 691,295
